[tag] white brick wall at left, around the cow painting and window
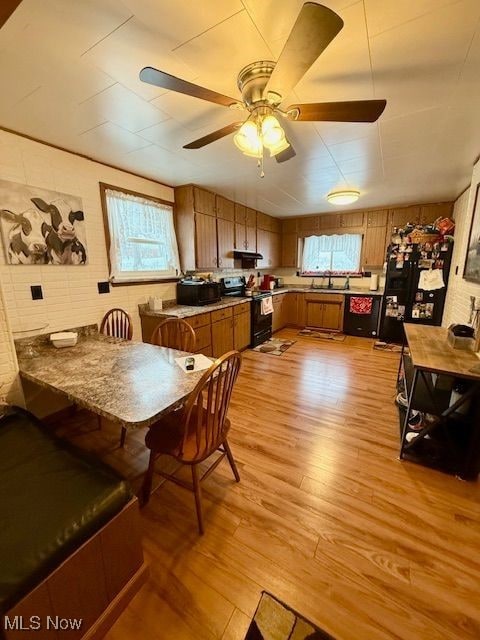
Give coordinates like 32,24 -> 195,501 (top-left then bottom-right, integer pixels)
0,131 -> 175,340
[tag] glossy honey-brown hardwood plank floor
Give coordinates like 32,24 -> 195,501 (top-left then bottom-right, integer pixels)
52,329 -> 480,640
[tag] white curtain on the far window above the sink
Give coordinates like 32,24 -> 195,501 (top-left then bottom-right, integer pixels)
302,234 -> 362,273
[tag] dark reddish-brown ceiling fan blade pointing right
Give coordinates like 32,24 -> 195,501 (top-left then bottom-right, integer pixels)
286,100 -> 387,122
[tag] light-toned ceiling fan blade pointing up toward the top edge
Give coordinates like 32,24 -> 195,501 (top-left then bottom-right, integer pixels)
264,2 -> 343,97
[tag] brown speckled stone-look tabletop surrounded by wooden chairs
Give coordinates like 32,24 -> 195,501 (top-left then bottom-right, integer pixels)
17,331 -> 208,428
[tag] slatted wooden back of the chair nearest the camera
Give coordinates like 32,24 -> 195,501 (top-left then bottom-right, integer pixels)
180,351 -> 242,462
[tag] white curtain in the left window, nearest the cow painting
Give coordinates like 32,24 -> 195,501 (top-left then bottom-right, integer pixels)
105,189 -> 180,282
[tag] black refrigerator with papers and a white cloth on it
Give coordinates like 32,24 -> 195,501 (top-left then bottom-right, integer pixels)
379,240 -> 453,343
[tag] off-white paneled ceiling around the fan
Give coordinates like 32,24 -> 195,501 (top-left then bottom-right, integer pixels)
0,0 -> 480,216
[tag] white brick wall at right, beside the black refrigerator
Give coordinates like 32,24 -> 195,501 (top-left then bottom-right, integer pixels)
443,161 -> 480,327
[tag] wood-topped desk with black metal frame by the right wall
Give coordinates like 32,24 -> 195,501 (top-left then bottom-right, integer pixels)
399,323 -> 480,480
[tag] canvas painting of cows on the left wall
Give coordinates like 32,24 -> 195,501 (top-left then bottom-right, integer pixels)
0,180 -> 87,265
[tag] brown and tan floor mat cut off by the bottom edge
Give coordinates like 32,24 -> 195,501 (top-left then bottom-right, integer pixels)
245,591 -> 335,640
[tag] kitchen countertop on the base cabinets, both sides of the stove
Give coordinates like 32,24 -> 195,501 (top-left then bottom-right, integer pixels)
138,285 -> 383,318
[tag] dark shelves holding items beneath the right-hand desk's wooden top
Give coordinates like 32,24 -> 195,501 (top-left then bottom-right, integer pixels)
396,351 -> 474,475
